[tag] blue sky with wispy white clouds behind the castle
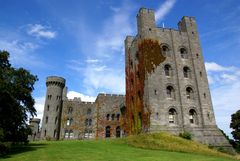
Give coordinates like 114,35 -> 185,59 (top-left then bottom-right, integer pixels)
0,0 -> 240,138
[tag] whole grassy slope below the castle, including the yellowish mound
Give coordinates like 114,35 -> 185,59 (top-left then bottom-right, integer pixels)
0,133 -> 239,161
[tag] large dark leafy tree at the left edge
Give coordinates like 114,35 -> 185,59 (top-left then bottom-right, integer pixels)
0,51 -> 38,142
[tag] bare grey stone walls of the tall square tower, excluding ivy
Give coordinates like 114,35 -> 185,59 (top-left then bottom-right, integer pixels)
125,8 -> 231,148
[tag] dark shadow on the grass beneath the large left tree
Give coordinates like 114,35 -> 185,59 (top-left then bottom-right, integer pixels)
0,143 -> 47,159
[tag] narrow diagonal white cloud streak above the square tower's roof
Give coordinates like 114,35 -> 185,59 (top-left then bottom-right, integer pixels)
155,0 -> 176,21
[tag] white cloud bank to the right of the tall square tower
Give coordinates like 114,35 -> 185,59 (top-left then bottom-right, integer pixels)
205,62 -> 240,136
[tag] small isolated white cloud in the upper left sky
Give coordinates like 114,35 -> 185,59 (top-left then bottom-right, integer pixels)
27,24 -> 57,39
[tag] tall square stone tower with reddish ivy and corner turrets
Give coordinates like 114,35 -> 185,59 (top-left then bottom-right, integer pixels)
124,8 -> 230,147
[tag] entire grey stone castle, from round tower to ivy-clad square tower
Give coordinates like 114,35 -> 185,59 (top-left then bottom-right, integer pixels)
35,8 -> 230,147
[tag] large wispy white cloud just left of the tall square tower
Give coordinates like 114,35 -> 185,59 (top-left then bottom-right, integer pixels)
68,1 -> 133,95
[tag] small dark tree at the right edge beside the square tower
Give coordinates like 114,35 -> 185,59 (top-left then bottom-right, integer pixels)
230,110 -> 240,142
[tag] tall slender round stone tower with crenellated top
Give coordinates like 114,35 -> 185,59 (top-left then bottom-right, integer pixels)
41,76 -> 65,140
